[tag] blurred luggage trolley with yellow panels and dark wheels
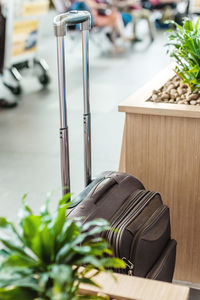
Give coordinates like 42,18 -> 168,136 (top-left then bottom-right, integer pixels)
0,0 -> 50,95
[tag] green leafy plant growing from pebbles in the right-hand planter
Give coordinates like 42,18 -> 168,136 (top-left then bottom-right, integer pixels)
167,19 -> 200,92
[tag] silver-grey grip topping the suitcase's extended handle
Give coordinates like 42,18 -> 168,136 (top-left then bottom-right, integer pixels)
53,10 -> 91,36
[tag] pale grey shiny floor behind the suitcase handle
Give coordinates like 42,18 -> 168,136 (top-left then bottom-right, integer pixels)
0,8 -> 200,300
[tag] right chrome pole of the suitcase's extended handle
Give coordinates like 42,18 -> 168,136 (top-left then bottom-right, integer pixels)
82,29 -> 91,186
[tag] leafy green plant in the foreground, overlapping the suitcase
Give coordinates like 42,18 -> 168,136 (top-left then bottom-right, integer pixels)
0,196 -> 125,300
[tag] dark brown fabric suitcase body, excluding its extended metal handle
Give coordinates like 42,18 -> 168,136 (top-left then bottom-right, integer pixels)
68,179 -> 175,280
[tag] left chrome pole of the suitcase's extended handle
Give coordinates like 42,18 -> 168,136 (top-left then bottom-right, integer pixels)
57,36 -> 70,196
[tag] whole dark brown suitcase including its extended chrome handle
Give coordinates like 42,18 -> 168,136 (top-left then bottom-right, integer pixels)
54,11 -> 176,281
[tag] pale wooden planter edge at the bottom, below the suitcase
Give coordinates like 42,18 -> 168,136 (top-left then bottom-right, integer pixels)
80,273 -> 189,300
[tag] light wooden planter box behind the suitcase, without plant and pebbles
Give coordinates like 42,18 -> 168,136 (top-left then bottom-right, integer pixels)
119,66 -> 200,283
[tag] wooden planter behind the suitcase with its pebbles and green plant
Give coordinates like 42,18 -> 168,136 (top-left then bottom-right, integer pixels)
119,20 -> 200,283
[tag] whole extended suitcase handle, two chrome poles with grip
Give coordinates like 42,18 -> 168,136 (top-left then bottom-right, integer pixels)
54,11 -> 91,195
